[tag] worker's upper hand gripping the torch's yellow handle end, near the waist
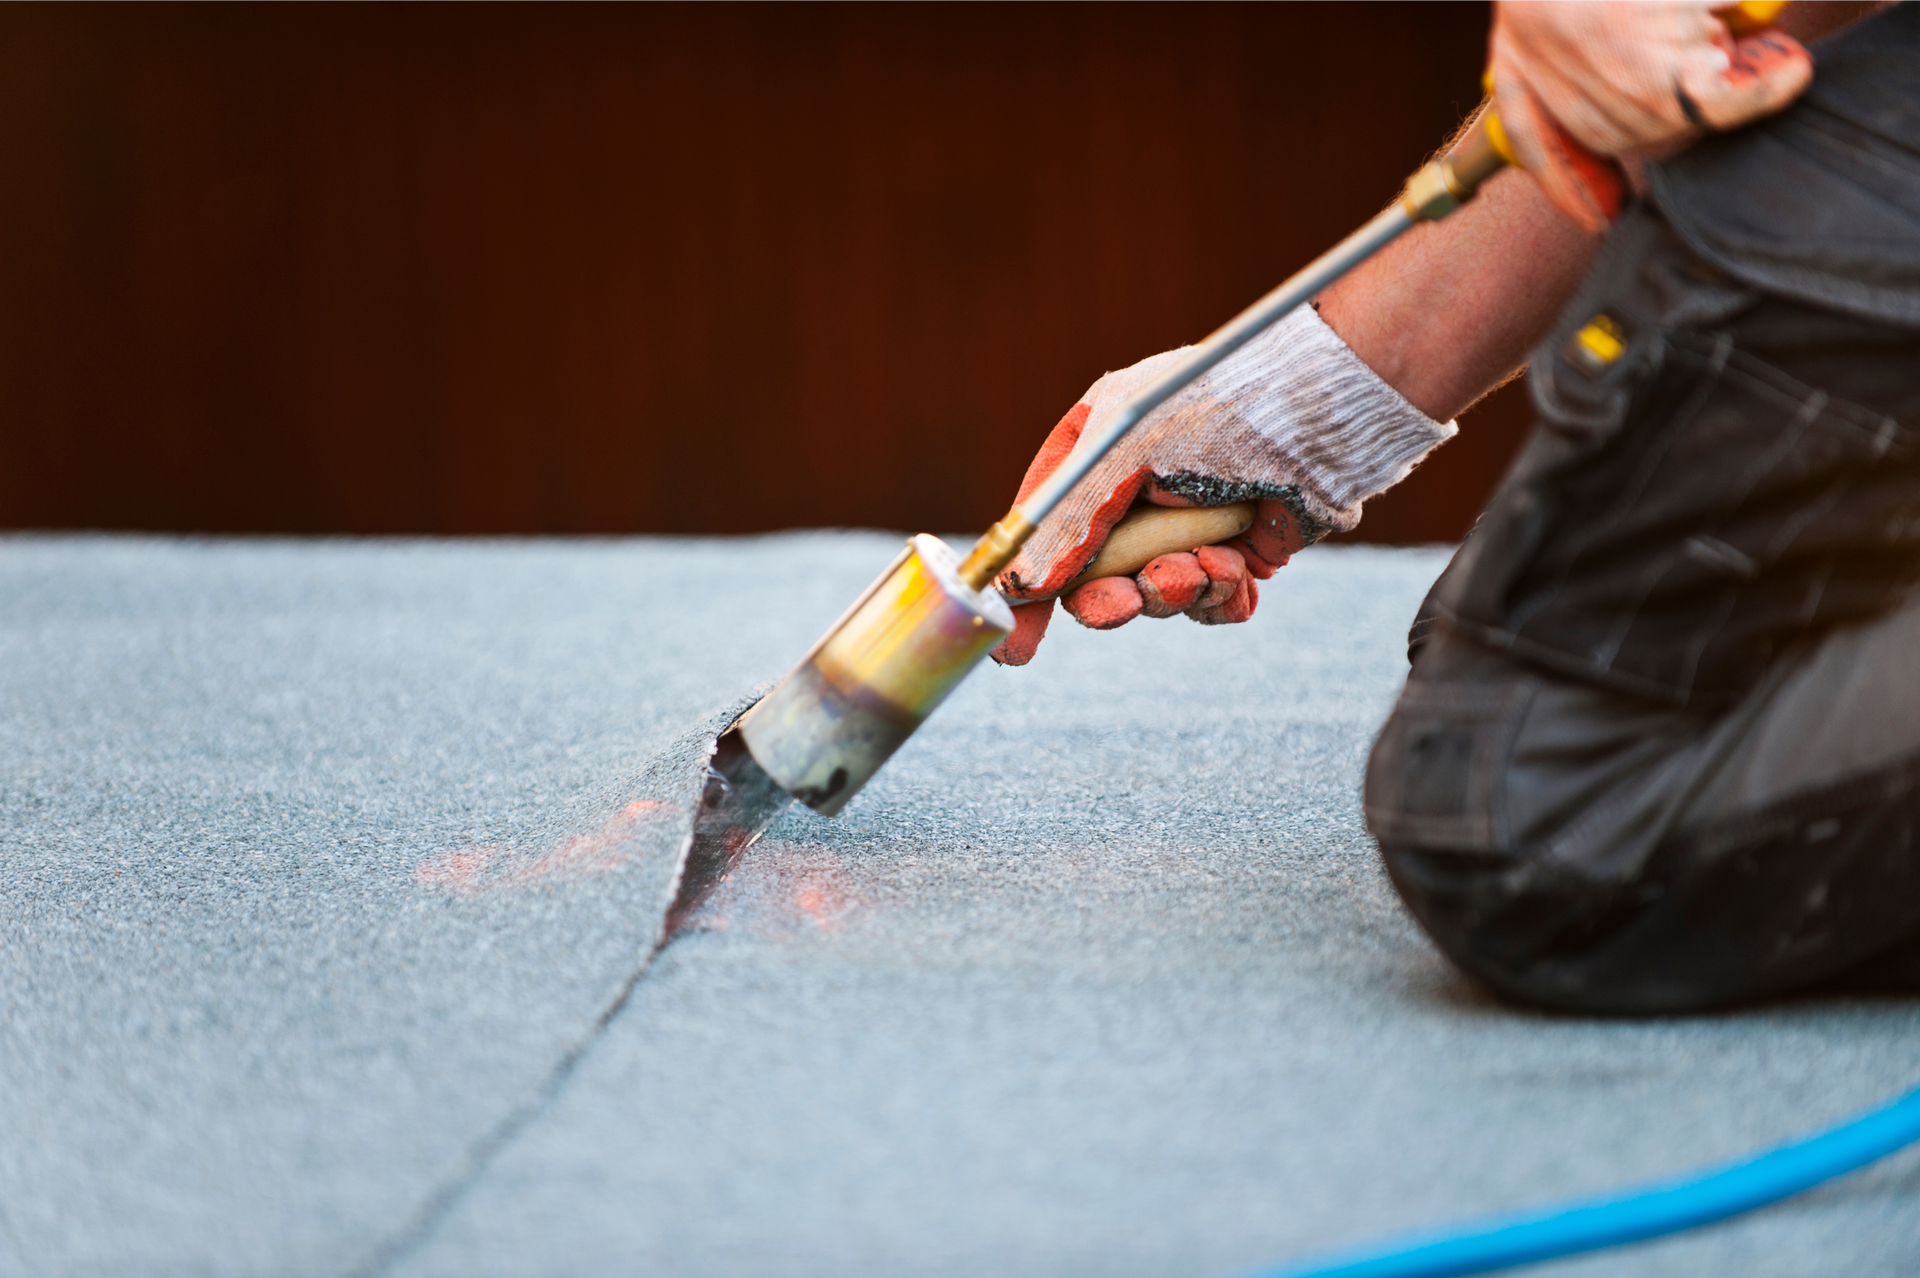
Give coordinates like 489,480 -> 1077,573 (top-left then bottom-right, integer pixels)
1488,0 -> 1812,230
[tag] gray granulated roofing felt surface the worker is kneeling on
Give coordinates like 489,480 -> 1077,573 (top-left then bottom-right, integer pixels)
0,533 -> 1920,1278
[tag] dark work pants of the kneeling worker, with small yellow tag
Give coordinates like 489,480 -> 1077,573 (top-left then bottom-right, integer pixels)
1367,209 -> 1920,1013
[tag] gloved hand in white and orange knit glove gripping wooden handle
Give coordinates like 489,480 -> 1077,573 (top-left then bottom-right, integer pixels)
993,307 -> 1453,666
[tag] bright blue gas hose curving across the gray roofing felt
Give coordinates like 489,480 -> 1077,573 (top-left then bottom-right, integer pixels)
1254,1090 -> 1920,1278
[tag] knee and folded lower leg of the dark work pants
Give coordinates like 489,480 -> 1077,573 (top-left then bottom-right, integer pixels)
1367,593 -> 1920,1011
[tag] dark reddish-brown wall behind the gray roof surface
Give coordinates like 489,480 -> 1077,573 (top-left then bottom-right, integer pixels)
0,0 -> 1524,541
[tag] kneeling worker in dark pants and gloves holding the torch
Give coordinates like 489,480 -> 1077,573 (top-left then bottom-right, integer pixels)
995,0 -> 1920,1011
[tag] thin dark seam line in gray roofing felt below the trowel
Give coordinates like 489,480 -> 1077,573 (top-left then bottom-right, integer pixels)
348,687 -> 766,1278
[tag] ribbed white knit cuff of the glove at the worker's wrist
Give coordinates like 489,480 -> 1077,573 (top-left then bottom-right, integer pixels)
1208,307 -> 1459,530
